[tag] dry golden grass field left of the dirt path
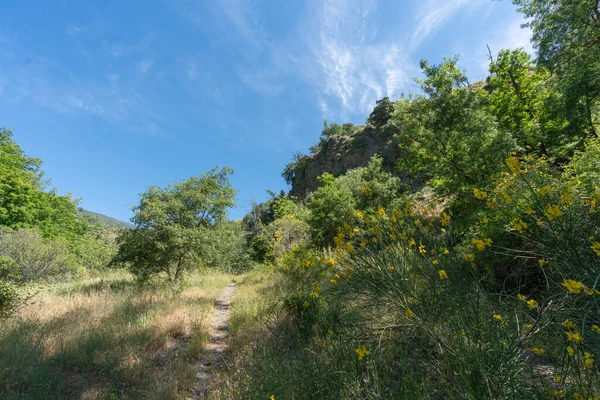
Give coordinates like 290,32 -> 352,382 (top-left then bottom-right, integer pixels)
0,271 -> 237,399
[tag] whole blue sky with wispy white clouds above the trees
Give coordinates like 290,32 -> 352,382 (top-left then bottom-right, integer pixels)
0,0 -> 531,220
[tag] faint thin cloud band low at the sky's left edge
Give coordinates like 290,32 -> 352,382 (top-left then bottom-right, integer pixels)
0,32 -> 169,135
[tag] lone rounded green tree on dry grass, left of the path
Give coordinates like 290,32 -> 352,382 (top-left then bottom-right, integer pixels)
114,167 -> 235,282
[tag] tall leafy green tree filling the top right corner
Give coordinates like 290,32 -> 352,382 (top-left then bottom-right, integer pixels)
513,0 -> 600,136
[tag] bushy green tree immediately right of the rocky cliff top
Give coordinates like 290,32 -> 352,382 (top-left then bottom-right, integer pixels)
394,58 -> 513,194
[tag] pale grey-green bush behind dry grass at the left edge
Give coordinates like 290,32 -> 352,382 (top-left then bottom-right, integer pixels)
0,229 -> 81,283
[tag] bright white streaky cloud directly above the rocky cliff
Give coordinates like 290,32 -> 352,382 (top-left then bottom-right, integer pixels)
306,0 -> 408,113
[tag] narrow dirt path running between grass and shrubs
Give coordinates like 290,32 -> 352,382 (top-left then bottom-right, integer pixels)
191,283 -> 235,399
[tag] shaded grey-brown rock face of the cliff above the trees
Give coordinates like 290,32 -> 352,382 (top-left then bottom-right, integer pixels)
290,126 -> 403,200
